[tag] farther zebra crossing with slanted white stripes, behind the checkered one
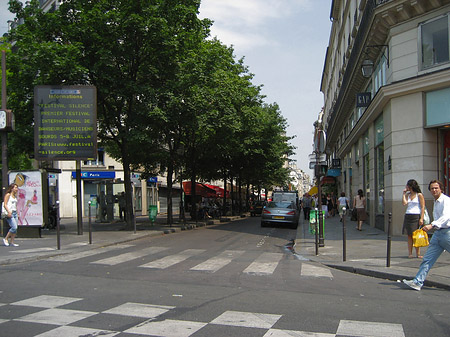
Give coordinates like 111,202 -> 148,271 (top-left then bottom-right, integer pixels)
47,244 -> 333,279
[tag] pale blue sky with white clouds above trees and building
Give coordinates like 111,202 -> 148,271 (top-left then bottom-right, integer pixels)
0,0 -> 331,174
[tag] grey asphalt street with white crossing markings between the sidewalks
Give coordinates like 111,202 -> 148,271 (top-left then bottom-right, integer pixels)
0,217 -> 450,337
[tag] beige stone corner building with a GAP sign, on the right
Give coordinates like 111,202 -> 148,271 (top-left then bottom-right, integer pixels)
321,0 -> 450,234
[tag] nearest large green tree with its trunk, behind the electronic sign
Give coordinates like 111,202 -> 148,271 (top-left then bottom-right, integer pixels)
10,0 -> 209,226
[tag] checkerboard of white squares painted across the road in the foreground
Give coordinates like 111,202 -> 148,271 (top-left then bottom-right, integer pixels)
0,291 -> 405,337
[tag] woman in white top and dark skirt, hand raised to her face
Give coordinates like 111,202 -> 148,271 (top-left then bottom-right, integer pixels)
402,179 -> 425,258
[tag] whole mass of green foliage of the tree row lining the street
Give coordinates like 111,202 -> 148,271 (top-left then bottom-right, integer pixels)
8,0 -> 294,192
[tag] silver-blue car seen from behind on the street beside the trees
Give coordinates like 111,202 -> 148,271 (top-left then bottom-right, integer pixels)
261,201 -> 299,229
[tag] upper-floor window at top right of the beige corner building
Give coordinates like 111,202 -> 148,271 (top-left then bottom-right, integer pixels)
420,15 -> 449,69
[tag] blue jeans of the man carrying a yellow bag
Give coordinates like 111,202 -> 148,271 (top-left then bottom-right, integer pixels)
414,228 -> 450,286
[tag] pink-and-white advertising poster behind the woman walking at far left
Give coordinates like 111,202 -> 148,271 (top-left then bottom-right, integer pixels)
9,171 -> 44,227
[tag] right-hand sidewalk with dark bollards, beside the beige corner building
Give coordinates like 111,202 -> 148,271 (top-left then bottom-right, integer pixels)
295,213 -> 450,290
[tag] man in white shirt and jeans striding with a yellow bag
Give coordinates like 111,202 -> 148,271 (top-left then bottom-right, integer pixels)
403,180 -> 450,290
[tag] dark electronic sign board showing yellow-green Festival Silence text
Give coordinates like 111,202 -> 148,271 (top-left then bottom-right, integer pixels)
34,85 -> 97,160
